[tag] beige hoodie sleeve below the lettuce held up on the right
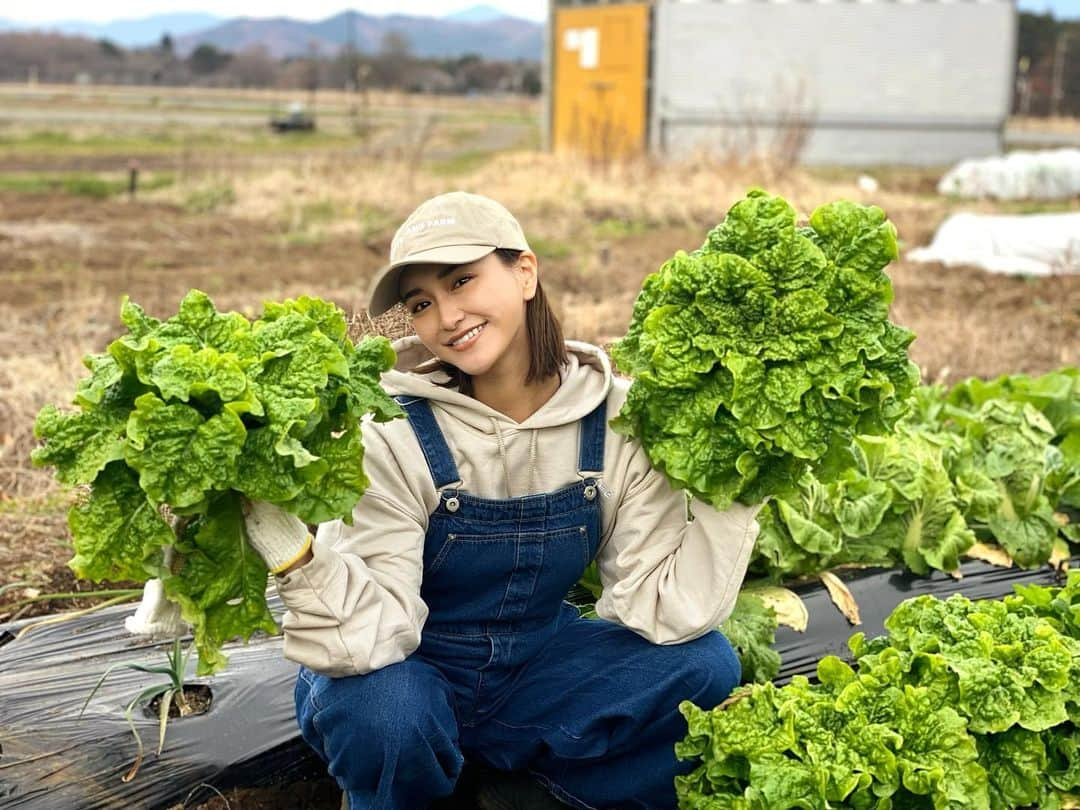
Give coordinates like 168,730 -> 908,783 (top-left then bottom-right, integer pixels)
596,434 -> 760,644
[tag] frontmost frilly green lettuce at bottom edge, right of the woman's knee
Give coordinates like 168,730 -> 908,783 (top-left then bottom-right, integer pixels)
675,657 -> 988,810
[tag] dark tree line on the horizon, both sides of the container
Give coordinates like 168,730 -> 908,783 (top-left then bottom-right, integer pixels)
0,12 -> 1080,116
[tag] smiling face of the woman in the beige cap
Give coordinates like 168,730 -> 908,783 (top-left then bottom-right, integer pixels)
397,253 -> 537,377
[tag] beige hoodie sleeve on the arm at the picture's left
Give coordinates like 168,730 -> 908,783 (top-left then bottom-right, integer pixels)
278,428 -> 428,677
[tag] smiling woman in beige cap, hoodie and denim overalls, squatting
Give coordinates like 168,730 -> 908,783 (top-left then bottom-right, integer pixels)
247,192 -> 758,810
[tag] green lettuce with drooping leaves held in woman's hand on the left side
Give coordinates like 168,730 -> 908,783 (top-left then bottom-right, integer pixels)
32,291 -> 402,674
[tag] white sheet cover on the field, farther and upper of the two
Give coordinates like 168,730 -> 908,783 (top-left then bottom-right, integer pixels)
937,149 -> 1080,200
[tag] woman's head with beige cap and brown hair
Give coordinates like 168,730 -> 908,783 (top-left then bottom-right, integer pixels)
370,192 -> 567,414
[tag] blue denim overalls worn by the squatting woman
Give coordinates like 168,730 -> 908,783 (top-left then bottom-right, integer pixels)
296,397 -> 740,810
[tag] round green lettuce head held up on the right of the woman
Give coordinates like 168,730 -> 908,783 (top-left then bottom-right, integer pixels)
612,190 -> 918,509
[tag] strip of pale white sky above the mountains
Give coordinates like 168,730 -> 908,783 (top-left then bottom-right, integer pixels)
0,0 -> 548,23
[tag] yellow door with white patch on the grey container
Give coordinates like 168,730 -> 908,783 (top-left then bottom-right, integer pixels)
552,3 -> 649,160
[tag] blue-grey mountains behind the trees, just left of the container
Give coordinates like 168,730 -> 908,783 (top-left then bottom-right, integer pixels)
173,10 -> 543,62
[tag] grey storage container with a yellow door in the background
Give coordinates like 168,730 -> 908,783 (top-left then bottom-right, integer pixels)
548,0 -> 1016,165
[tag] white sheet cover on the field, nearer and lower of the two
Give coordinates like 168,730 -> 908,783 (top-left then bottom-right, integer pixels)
907,213 -> 1080,275
